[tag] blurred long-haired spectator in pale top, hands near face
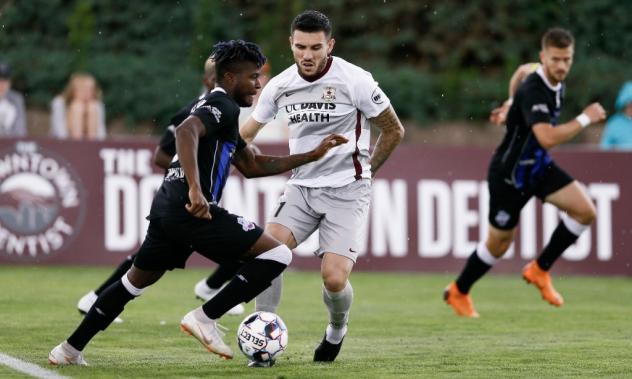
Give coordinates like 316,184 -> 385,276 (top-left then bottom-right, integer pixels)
50,73 -> 105,140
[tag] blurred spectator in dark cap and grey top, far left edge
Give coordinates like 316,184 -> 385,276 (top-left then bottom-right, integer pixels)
0,62 -> 26,138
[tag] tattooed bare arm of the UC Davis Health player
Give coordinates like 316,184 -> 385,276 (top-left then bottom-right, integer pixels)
369,106 -> 404,176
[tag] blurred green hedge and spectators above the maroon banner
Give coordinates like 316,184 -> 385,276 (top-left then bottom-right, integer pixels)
0,0 -> 632,149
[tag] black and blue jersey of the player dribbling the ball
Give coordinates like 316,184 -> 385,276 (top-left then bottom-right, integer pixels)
149,89 -> 246,218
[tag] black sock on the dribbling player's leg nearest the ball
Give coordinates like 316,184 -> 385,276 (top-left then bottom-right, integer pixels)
202,259 -> 287,319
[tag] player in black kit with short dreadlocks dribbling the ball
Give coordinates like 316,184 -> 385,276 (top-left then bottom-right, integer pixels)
48,41 -> 347,365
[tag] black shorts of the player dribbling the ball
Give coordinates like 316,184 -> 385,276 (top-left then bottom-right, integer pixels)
134,205 -> 263,271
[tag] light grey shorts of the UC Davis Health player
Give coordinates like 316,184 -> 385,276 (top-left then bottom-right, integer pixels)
268,179 -> 371,262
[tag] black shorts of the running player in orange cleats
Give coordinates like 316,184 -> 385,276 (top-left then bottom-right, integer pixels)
487,162 -> 574,230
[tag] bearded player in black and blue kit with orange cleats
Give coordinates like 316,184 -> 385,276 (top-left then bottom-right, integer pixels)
443,28 -> 605,317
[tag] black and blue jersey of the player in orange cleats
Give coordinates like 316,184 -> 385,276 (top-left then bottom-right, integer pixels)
490,67 -> 564,189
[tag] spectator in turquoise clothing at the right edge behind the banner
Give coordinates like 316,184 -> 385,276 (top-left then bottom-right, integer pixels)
601,81 -> 632,150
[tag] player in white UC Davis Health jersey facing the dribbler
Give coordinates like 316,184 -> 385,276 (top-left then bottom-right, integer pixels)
241,11 -> 404,362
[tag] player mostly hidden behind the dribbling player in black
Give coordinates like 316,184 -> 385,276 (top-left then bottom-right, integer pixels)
77,57 -> 247,323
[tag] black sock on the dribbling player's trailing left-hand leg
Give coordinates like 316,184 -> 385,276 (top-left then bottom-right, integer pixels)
67,280 -> 134,350
